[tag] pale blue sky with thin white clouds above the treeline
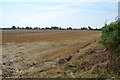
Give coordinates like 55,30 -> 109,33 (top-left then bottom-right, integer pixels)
0,0 -> 119,28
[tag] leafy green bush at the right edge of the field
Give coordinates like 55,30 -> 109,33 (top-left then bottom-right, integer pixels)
100,21 -> 120,51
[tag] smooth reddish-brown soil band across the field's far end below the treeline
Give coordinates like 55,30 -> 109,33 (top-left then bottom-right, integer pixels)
2,30 -> 100,43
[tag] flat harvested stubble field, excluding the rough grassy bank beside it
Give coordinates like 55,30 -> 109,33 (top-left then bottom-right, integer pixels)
2,30 -> 101,77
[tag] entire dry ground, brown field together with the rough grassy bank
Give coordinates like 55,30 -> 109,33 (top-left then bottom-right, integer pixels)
2,30 -> 116,78
